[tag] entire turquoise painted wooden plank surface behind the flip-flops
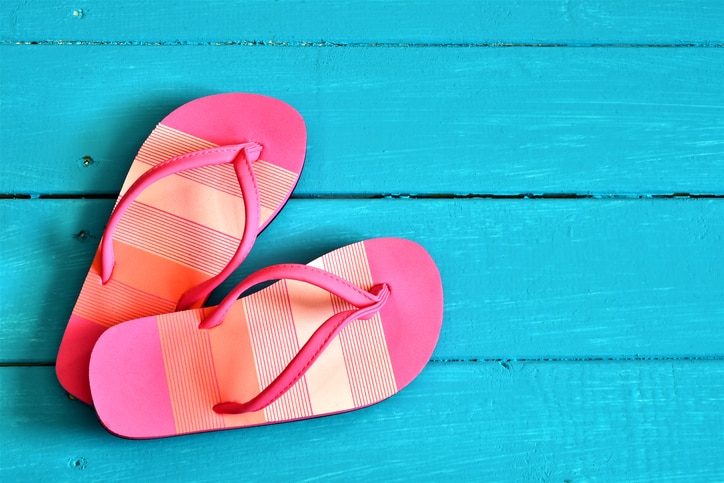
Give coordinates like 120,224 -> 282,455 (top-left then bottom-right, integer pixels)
0,0 -> 724,482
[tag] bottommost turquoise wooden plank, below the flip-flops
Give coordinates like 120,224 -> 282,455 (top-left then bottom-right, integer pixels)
0,361 -> 724,482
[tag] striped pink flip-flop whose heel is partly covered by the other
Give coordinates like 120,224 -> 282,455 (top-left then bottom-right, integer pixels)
56,93 -> 306,403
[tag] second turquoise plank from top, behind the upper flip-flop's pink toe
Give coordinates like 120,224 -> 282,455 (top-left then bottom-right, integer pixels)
0,45 -> 724,195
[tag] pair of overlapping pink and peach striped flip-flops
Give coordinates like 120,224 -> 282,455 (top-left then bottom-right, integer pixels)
56,93 -> 442,438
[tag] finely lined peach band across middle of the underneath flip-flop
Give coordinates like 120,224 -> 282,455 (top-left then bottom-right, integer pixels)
115,202 -> 239,275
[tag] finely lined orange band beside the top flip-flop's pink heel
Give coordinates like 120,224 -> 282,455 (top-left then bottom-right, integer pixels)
156,309 -> 225,433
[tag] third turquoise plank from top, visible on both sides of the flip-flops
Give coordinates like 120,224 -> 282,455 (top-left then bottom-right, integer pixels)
0,199 -> 724,362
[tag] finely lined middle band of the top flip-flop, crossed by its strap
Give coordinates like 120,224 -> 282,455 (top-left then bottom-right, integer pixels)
243,281 -> 312,421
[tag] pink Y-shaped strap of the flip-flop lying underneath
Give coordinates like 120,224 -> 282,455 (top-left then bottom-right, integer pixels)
101,142 -> 262,310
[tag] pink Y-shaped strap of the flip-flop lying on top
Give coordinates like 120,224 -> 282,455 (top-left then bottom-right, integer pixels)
199,264 -> 390,414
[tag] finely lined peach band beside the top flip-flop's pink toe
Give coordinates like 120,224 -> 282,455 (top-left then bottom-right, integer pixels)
322,242 -> 397,406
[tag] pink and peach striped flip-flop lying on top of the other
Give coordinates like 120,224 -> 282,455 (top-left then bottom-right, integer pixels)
89,238 -> 443,439
